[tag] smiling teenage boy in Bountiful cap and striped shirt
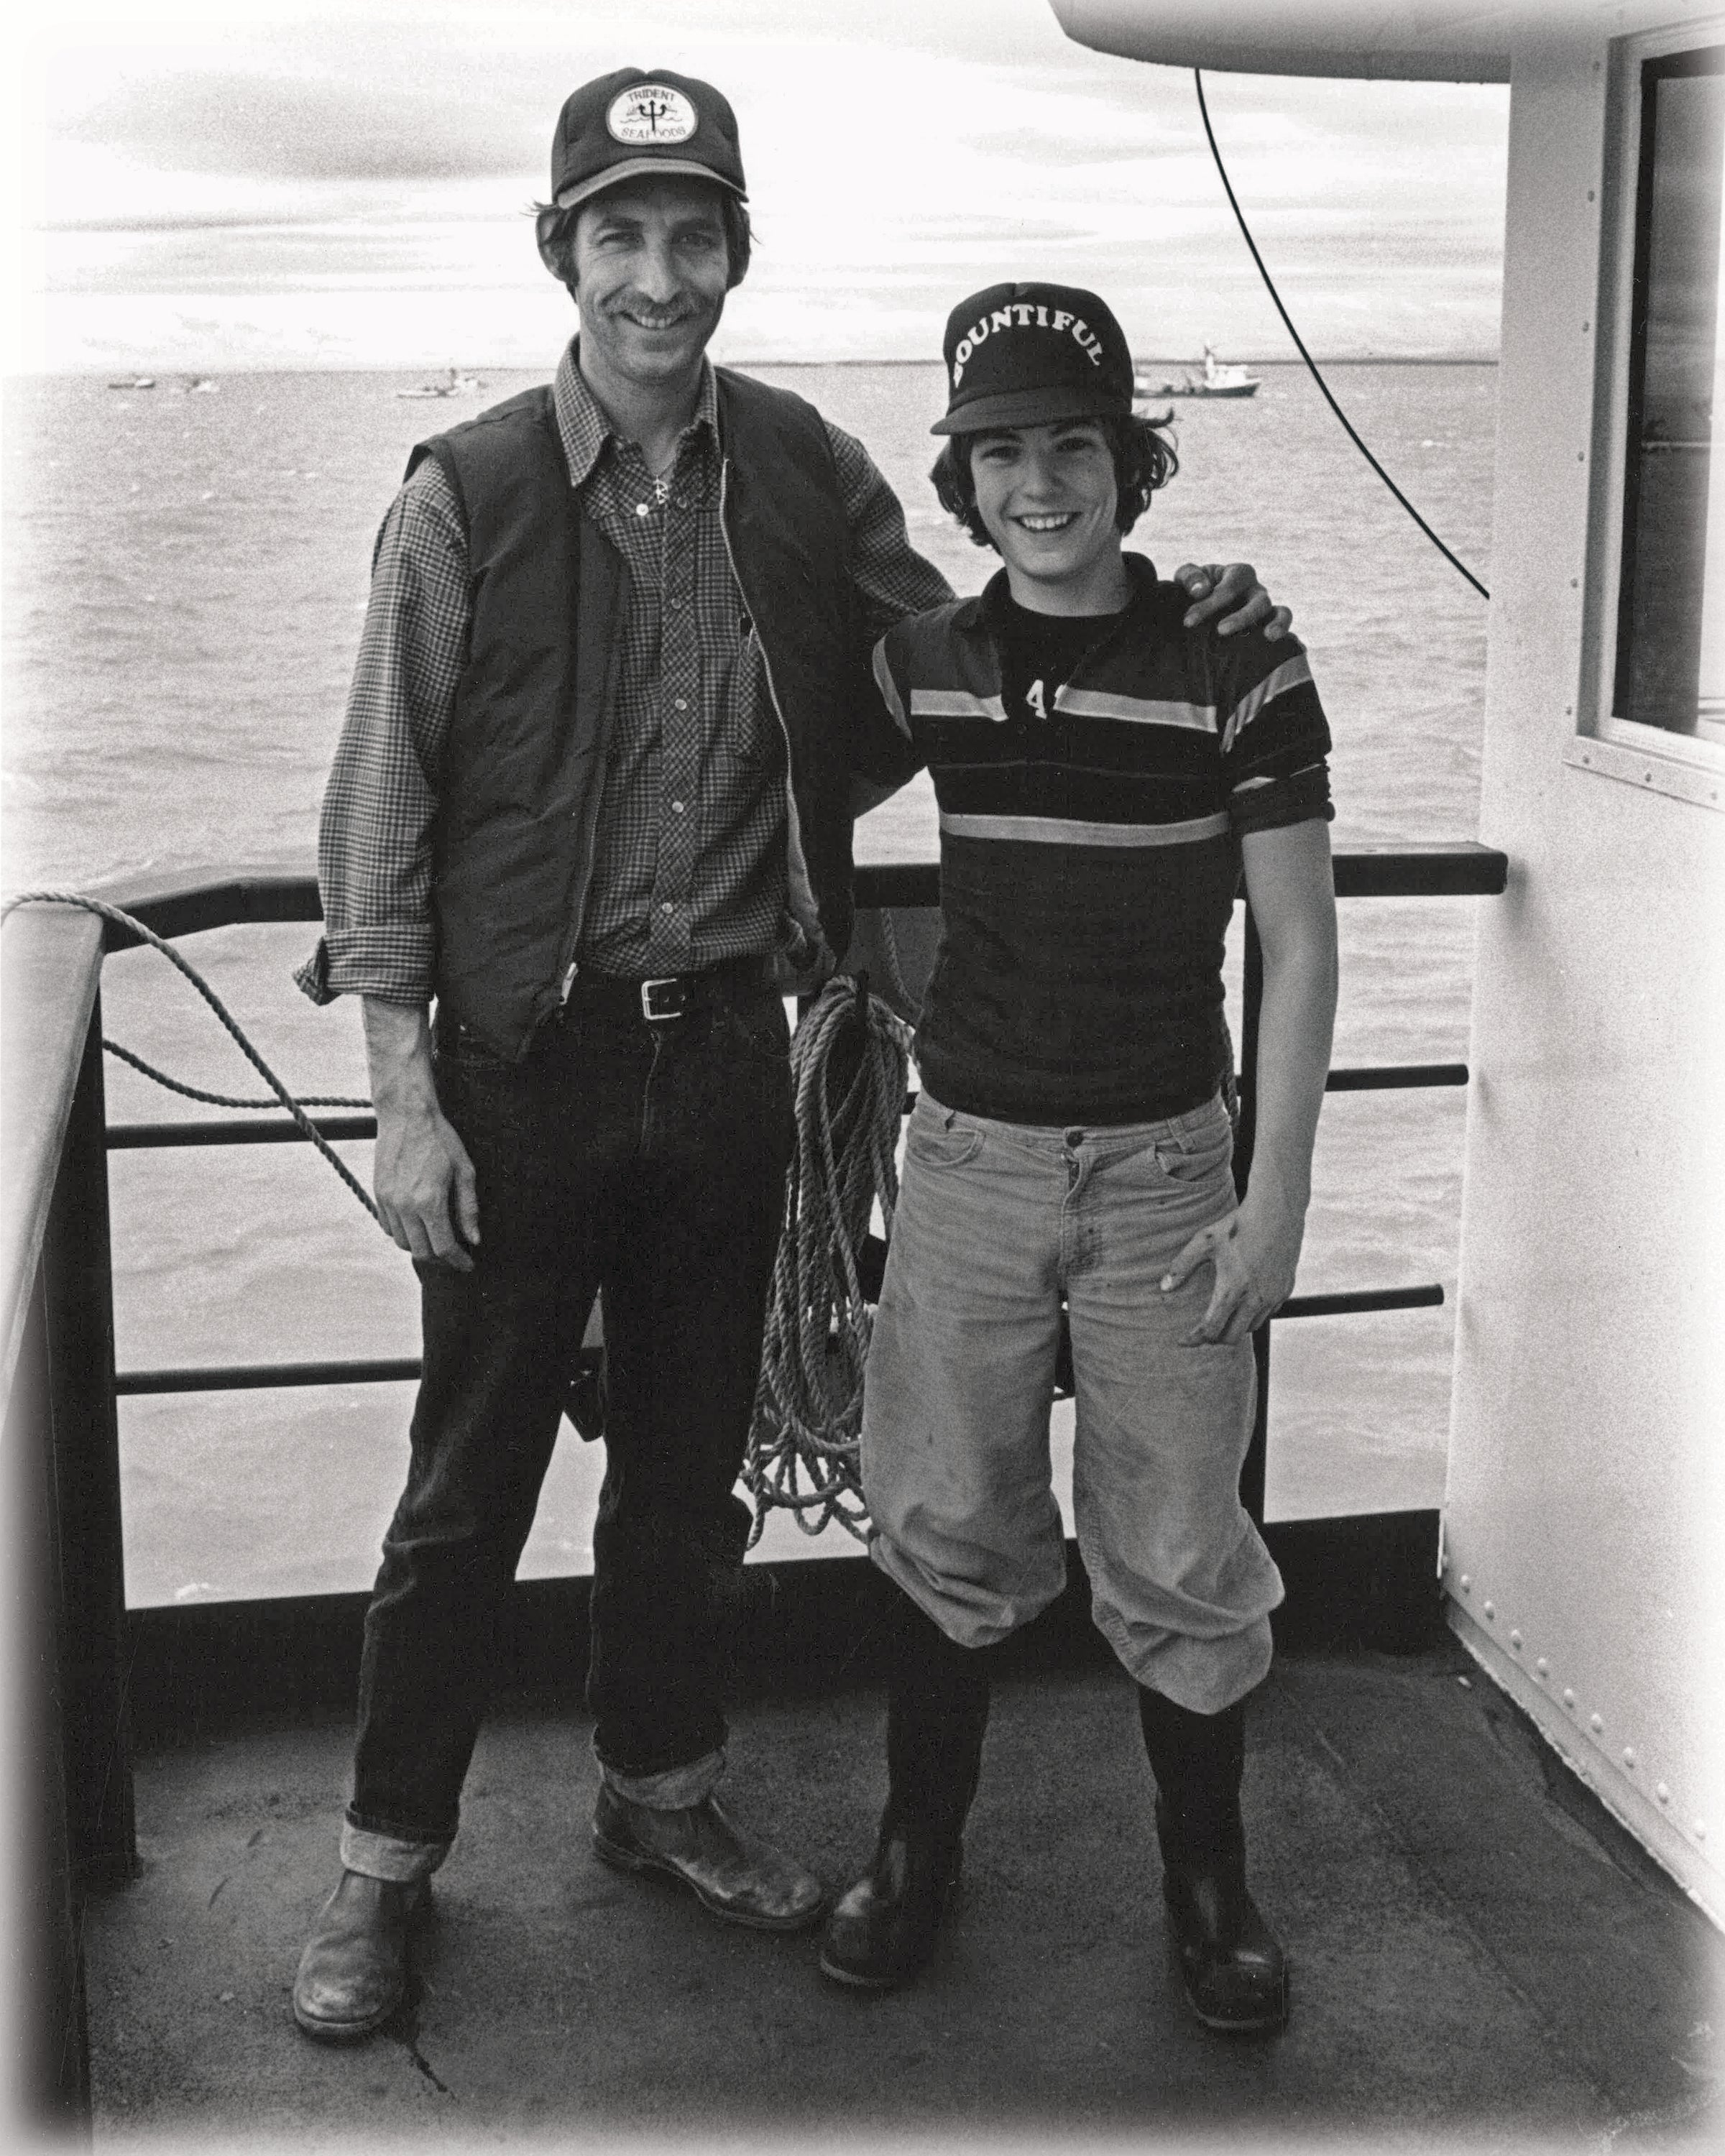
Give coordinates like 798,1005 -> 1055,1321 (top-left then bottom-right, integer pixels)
822,285 -> 1335,2031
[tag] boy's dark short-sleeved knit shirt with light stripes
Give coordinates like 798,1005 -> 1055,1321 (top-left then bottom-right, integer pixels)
875,554 -> 1333,1125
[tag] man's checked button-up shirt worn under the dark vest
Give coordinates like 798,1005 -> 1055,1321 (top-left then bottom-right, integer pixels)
295,343 -> 951,1003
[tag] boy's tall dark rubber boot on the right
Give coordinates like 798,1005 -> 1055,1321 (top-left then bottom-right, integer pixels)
1138,1684 -> 1287,2033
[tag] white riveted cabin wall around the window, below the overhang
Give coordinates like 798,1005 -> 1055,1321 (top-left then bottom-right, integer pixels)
1445,29 -> 1725,1921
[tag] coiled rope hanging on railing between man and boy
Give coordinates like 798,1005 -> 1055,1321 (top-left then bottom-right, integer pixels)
744,975 -> 910,1544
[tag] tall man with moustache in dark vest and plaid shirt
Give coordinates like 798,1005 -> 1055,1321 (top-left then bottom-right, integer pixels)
293,69 -> 1287,2040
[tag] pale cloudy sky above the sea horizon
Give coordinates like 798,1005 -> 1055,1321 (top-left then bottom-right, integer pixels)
0,0 -> 1507,373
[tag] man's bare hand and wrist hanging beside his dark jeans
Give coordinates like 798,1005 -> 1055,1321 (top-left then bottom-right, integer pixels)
364,996 -> 479,1272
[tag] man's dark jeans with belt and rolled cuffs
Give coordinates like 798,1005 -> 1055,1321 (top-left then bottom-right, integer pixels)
347,987 -> 791,1843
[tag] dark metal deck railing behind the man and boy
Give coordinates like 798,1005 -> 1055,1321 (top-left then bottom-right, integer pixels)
0,845 -> 1507,2117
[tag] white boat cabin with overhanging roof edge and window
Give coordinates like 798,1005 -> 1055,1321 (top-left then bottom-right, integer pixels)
1052,0 -> 1725,1921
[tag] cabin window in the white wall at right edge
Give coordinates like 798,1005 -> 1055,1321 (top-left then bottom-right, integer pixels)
1611,45 -> 1725,744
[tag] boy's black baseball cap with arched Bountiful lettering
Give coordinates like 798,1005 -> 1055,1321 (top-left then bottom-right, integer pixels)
929,285 -> 1132,433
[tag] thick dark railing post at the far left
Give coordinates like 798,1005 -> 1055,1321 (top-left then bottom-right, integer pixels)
41,996 -> 136,1889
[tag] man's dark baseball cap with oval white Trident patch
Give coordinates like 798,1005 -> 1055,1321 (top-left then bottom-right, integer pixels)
552,67 -> 748,209
